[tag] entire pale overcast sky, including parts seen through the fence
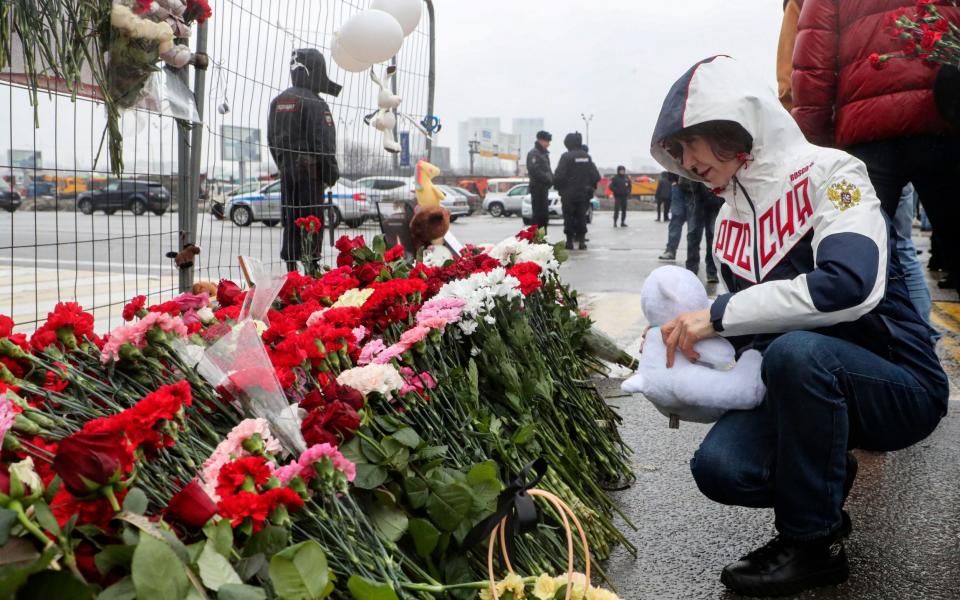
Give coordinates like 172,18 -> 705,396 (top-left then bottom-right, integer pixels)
0,0 -> 782,177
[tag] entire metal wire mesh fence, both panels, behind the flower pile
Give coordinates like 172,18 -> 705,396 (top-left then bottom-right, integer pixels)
0,0 -> 433,330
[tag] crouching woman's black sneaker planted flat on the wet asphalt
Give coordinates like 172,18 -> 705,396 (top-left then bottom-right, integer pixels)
720,535 -> 850,596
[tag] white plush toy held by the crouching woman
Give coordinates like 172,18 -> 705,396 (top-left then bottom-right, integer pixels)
621,266 -> 766,427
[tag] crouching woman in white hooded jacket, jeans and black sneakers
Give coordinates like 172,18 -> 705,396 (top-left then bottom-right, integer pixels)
651,56 -> 949,596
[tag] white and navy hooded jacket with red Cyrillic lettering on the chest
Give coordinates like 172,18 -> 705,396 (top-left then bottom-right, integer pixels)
651,56 -> 949,411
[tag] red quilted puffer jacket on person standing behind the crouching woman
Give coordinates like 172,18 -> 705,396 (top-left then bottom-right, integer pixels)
791,0 -> 960,148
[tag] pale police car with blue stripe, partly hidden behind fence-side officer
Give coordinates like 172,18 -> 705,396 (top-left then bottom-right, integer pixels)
224,180 -> 375,228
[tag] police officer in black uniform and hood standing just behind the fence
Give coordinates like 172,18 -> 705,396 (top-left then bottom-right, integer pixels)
267,48 -> 341,271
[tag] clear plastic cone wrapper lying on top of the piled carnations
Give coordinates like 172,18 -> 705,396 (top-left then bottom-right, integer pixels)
196,320 -> 307,454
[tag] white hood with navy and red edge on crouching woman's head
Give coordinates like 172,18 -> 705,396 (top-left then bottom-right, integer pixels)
650,56 -> 810,188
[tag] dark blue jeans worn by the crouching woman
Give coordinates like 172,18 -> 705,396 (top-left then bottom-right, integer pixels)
690,331 -> 943,540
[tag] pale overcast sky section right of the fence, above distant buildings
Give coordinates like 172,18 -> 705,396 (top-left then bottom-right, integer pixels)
435,0 -> 782,167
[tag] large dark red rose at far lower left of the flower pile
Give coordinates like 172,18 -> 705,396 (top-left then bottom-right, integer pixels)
53,431 -> 133,496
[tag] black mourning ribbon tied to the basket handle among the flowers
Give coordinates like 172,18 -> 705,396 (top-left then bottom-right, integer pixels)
461,457 -> 547,556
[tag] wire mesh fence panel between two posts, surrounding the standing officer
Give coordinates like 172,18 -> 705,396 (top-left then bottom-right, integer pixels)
197,0 -> 430,288
